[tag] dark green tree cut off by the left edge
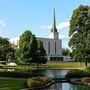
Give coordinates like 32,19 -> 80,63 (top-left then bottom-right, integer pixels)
0,37 -> 15,62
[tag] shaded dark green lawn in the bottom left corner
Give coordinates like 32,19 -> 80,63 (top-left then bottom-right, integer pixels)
0,77 -> 27,90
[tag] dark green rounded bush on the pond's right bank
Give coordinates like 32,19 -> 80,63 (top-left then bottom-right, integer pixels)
66,69 -> 85,78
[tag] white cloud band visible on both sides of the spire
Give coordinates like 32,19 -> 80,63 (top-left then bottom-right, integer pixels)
40,21 -> 70,30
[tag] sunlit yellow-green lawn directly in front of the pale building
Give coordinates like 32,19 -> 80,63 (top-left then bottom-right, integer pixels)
42,62 -> 85,69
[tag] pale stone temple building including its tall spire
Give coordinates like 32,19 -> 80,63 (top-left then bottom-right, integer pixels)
10,8 -> 68,61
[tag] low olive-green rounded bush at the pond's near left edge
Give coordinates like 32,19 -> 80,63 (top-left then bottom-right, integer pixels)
27,76 -> 50,88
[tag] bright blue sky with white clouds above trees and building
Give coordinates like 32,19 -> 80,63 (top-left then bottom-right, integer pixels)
0,0 -> 90,48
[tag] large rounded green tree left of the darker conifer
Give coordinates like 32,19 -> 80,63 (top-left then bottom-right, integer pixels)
16,30 -> 37,64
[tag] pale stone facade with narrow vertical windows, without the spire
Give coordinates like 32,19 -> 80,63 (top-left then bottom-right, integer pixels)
37,38 -> 62,61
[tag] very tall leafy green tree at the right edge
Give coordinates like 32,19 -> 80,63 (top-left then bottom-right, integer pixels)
69,5 -> 90,65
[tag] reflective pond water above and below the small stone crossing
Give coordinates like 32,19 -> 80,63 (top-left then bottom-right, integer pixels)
43,70 -> 90,90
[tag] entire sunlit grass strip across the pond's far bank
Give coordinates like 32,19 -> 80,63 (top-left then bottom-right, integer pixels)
0,62 -> 90,71
